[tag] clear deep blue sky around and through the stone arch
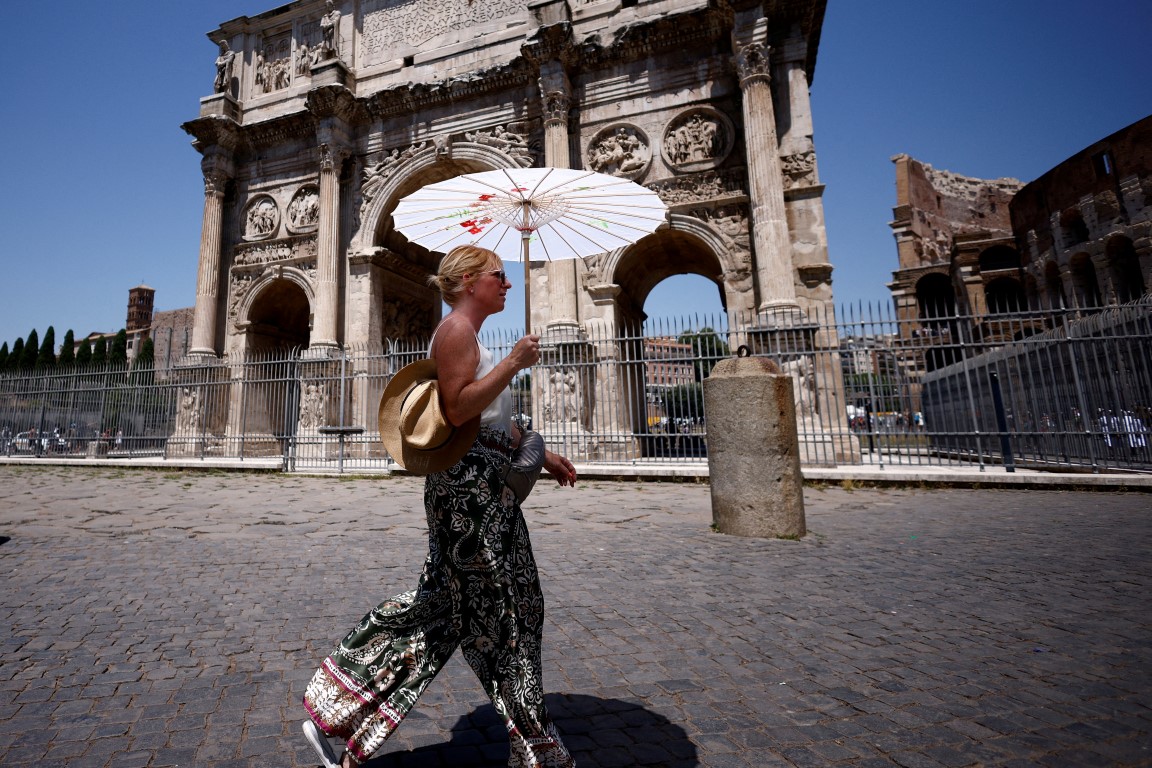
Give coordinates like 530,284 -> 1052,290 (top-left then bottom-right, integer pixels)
0,0 -> 1152,348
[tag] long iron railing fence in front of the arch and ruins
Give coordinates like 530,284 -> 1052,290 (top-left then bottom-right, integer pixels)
0,297 -> 1152,472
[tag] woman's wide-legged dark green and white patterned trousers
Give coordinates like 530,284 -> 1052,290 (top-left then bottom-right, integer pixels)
304,429 -> 576,768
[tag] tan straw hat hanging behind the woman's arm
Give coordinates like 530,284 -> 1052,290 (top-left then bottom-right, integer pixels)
380,359 -> 480,474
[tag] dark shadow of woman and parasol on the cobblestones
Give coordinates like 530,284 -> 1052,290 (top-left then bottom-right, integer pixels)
364,694 -> 699,768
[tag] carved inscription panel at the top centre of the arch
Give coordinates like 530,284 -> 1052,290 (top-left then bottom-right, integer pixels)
361,0 -> 525,67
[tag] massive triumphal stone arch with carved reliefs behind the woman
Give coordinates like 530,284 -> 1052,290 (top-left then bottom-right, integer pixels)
183,0 -> 850,455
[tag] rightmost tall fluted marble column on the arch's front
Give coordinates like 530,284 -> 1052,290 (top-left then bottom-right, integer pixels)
733,18 -> 799,312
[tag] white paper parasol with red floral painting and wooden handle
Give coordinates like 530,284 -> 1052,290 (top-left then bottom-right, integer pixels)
392,168 -> 668,333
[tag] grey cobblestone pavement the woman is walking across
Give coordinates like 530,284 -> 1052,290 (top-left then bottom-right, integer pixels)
0,466 -> 1152,768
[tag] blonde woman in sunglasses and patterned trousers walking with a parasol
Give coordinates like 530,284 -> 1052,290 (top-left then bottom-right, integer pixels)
304,245 -> 576,768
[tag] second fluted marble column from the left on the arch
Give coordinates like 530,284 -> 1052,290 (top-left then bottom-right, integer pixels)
309,142 -> 348,349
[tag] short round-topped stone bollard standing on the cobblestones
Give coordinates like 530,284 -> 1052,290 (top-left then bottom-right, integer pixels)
704,357 -> 808,539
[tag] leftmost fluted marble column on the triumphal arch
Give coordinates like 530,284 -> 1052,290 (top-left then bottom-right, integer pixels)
188,154 -> 235,357
